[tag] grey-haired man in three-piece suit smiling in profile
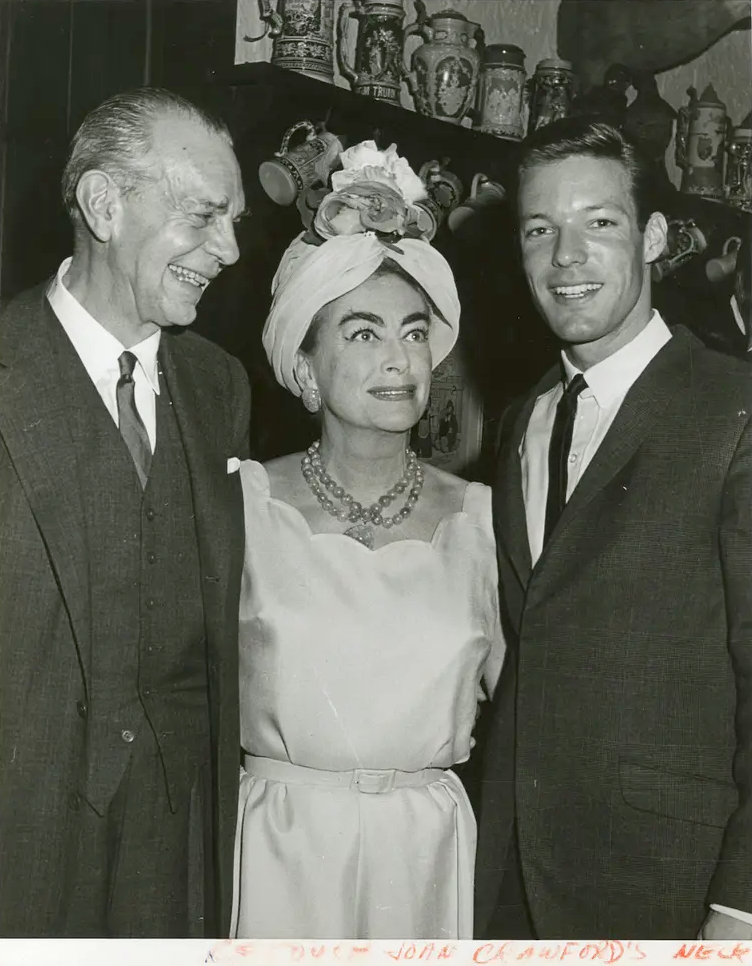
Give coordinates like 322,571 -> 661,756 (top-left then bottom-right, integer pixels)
0,89 -> 249,937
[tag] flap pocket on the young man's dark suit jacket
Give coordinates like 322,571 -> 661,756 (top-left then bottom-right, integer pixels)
619,758 -> 739,828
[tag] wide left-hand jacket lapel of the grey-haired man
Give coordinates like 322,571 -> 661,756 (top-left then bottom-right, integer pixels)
0,298 -> 91,677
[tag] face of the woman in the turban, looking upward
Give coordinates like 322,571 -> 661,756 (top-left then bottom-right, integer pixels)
299,274 -> 431,433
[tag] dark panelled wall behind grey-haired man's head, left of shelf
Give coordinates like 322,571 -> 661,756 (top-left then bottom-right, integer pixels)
0,0 -> 236,302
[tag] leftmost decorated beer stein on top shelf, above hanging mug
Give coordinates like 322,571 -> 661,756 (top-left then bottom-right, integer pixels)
245,0 -> 334,84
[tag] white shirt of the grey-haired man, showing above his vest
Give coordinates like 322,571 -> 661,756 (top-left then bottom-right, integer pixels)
47,258 -> 162,452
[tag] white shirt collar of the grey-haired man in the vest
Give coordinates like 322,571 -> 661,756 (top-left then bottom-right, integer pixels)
47,258 -> 162,395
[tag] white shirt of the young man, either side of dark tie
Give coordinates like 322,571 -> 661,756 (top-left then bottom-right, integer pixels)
520,310 -> 671,564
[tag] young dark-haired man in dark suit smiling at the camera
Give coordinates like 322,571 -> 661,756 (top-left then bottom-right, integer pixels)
477,118 -> 752,939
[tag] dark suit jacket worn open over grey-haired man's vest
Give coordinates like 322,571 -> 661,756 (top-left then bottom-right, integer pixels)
0,286 -> 250,935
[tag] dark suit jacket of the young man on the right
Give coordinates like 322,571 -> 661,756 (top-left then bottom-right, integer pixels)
476,328 -> 752,939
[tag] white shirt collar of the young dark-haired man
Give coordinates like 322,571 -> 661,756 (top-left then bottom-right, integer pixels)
561,309 -> 671,409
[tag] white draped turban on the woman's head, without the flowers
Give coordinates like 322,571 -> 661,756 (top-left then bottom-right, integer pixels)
262,232 -> 460,396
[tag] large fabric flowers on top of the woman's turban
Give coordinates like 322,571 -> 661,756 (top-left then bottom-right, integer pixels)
313,141 -> 427,244
